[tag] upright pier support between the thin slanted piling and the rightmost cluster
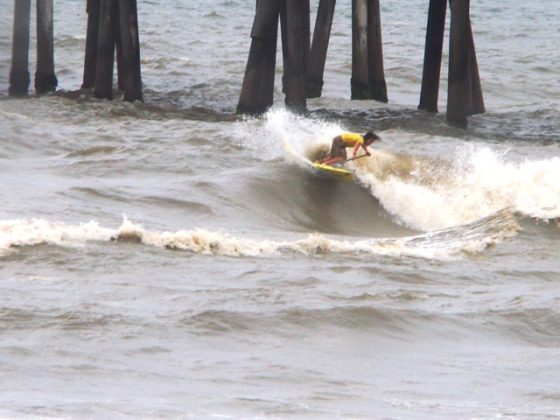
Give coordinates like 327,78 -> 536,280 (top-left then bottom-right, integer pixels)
351,0 -> 387,102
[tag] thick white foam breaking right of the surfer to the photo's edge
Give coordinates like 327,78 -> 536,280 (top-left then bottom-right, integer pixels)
357,147 -> 560,231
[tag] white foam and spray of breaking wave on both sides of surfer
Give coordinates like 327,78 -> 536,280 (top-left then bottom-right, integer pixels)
233,110 -> 560,232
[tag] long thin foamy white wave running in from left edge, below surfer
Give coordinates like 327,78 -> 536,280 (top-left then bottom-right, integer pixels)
0,210 -> 519,260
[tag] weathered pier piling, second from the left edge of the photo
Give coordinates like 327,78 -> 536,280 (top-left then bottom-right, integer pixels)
35,0 -> 58,94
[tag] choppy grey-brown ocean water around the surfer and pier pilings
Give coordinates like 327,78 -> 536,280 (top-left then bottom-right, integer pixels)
0,0 -> 560,419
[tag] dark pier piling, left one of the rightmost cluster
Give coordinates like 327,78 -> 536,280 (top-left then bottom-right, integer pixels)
418,0 -> 447,112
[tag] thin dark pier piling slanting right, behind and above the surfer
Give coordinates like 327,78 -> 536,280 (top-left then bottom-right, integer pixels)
307,0 -> 336,98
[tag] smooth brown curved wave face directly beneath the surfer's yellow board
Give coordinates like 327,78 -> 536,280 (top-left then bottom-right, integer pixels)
243,165 -> 418,237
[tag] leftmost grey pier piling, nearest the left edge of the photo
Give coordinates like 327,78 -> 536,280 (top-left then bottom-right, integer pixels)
8,0 -> 31,96
